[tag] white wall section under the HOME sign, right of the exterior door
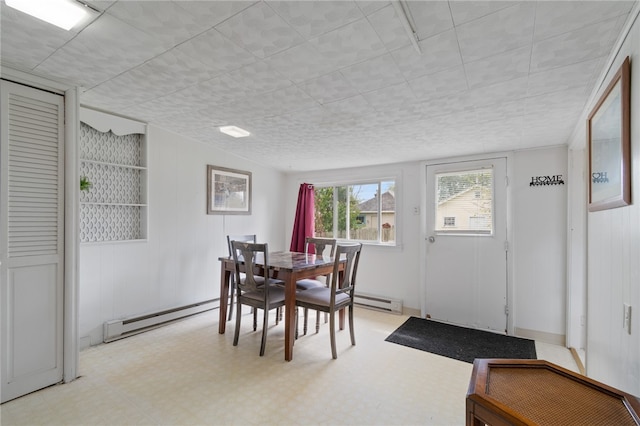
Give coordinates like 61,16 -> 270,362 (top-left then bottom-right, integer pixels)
510,147 -> 567,345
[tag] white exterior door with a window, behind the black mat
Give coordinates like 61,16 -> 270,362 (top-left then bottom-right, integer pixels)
425,158 -> 508,333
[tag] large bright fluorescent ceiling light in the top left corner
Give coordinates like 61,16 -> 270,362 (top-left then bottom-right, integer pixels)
5,0 -> 93,30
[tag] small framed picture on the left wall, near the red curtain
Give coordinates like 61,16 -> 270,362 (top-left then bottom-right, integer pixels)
207,165 -> 251,214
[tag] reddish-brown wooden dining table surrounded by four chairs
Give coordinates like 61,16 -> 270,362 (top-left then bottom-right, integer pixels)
218,251 -> 344,361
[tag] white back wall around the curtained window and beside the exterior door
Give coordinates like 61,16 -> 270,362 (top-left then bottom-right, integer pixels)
285,147 -> 567,344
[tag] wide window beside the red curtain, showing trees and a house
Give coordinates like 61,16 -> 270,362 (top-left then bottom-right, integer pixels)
315,180 -> 396,244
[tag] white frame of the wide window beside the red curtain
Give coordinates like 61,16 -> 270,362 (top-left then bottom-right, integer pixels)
314,176 -> 401,247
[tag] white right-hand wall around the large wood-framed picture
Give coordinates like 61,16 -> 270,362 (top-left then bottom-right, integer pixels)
570,5 -> 640,395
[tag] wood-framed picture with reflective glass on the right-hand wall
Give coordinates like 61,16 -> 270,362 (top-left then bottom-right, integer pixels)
587,57 -> 631,212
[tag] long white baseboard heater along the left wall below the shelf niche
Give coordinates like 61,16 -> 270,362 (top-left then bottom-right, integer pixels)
103,299 -> 220,343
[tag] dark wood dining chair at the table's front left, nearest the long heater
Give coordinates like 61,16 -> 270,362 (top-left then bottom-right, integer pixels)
231,241 -> 284,356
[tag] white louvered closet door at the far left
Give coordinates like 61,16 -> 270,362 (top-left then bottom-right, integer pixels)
0,81 -> 64,402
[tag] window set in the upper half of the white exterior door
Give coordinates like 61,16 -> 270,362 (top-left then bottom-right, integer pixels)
436,169 -> 493,235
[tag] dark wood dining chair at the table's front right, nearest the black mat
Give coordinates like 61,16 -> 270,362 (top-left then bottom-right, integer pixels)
296,243 -> 362,359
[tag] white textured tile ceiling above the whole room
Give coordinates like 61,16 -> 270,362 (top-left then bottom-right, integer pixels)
0,0 -> 634,171
